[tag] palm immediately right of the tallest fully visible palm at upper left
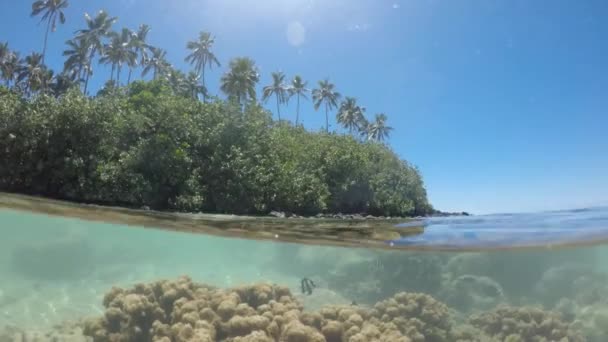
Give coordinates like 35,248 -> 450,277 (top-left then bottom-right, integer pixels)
99,28 -> 137,86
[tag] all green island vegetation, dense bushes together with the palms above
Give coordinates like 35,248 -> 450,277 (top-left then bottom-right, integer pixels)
0,0 -> 433,216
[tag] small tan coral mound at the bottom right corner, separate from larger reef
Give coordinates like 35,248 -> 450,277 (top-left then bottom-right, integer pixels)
469,306 -> 586,342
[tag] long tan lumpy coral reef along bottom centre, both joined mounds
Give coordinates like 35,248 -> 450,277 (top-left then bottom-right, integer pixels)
84,277 -> 451,342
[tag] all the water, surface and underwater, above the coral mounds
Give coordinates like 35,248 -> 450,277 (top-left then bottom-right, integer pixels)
0,196 -> 608,342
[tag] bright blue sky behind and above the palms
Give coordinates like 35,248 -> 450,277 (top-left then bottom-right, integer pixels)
0,0 -> 608,213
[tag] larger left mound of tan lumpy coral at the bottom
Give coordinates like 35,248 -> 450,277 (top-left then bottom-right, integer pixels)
84,277 -> 308,342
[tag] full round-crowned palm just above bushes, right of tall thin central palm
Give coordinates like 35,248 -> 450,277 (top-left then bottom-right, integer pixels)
220,57 -> 260,107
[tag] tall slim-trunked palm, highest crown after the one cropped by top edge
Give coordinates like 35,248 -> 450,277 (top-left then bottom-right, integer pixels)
76,10 -> 116,94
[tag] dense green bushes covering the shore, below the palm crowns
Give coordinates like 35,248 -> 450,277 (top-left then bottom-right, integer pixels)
0,82 -> 432,216
